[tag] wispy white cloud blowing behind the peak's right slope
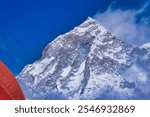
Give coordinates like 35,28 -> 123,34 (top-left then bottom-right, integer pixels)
94,3 -> 150,45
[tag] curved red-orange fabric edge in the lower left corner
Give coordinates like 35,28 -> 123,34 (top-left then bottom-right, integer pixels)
0,62 -> 25,100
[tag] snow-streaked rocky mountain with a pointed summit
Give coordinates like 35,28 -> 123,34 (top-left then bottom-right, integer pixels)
17,18 -> 150,99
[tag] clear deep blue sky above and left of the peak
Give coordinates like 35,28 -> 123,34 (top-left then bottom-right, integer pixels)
0,0 -> 150,75
